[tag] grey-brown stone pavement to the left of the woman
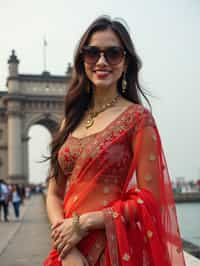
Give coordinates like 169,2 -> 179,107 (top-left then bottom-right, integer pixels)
0,195 -> 50,266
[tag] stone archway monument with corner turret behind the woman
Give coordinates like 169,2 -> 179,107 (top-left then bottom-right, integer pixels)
0,51 -> 71,183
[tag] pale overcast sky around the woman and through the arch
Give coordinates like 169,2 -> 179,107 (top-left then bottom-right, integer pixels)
0,0 -> 200,182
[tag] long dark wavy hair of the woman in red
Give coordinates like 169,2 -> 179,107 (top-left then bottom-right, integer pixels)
49,16 -> 150,182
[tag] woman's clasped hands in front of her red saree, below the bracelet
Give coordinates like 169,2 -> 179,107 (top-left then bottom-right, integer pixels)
51,218 -> 87,258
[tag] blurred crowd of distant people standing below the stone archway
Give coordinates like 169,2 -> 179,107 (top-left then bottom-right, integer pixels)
0,179 -> 41,222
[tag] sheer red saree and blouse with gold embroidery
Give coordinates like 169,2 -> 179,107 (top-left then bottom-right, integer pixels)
44,104 -> 185,266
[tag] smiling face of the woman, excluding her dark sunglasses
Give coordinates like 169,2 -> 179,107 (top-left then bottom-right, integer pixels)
84,29 -> 126,89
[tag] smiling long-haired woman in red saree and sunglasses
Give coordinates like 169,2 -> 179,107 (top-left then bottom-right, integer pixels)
44,17 -> 185,266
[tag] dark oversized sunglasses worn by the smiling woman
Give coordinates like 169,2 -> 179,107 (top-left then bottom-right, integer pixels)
81,46 -> 126,65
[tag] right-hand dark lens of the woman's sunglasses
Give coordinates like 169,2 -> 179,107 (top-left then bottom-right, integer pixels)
105,47 -> 124,65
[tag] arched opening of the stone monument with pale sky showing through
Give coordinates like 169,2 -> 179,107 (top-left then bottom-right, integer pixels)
28,124 -> 52,183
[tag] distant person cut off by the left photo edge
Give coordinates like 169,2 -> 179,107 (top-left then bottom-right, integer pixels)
0,179 -> 9,222
